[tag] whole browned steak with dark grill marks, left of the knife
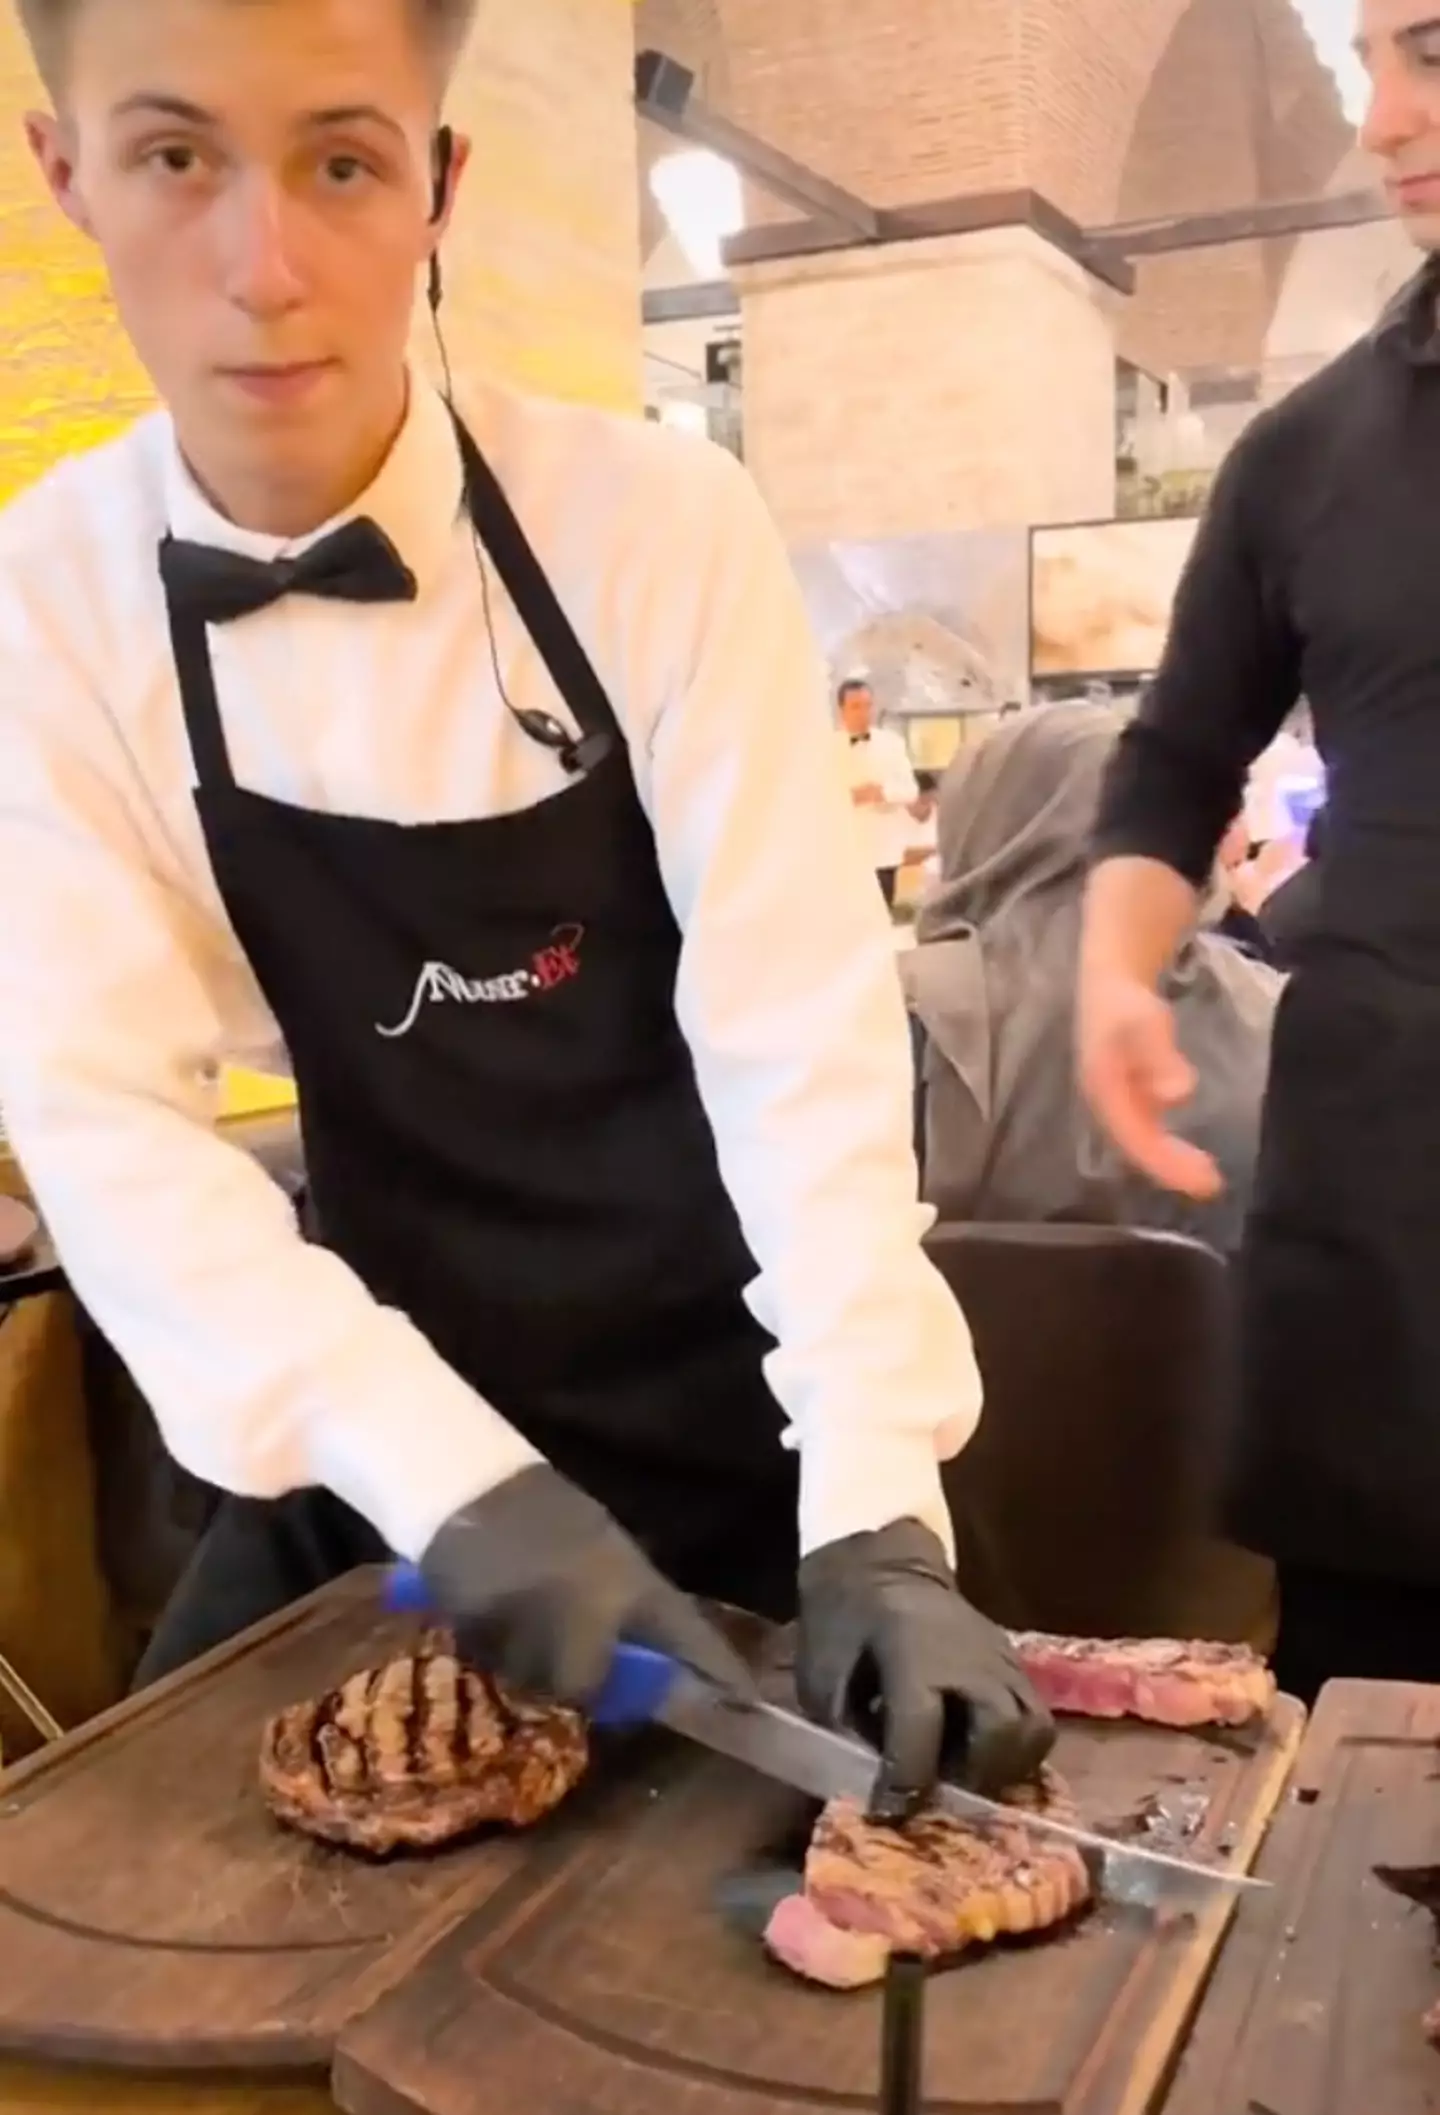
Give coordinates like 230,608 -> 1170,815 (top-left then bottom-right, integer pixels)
260,1637 -> 588,1857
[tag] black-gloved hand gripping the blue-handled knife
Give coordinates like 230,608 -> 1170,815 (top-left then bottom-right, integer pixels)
421,1461 -> 753,1705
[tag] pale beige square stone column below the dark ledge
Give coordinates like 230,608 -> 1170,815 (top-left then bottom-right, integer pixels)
736,228 -> 1121,546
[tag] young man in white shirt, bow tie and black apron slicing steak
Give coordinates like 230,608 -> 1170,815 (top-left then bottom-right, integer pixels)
0,0 -> 1049,1800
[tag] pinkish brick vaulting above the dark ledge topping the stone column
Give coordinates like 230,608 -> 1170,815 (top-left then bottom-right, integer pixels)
636,0 -> 1349,302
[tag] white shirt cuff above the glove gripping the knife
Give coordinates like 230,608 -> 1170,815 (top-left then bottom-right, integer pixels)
309,1316 -> 543,1563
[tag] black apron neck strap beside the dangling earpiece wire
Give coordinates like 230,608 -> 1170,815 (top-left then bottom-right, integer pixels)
450,406 -> 620,772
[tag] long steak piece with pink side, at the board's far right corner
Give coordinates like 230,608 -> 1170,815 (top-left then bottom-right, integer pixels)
1013,1631 -> 1275,1726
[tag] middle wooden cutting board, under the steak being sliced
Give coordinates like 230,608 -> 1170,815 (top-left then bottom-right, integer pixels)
332,1703 -> 1303,2115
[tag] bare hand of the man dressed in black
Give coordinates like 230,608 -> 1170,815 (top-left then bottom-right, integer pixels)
1078,977 -> 1224,1199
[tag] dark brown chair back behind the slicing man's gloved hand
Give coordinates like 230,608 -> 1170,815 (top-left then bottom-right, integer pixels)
926,1225 -> 1275,1648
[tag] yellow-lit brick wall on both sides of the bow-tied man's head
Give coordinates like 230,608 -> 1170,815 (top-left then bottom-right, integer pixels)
0,0 -> 641,499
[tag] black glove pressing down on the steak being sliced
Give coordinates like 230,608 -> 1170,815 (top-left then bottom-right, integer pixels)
795,1521 -> 1055,1821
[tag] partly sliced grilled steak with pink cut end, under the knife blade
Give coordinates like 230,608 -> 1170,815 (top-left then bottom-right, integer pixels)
765,1770 -> 1091,1990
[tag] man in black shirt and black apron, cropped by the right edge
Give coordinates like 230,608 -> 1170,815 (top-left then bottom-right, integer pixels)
1078,0 -> 1440,1696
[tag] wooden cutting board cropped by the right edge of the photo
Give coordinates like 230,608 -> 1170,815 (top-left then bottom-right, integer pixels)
1165,1681 -> 1440,2115
